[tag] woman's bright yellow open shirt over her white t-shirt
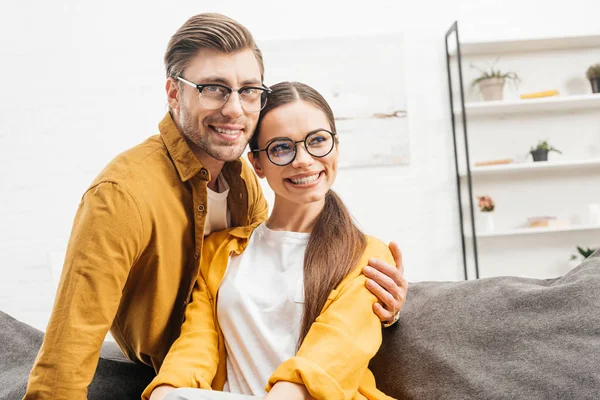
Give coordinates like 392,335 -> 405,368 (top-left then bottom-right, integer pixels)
142,226 -> 394,400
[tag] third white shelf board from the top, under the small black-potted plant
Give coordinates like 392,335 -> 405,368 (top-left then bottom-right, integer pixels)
460,158 -> 600,178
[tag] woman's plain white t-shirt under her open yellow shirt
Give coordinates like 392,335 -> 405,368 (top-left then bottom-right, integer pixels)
217,222 -> 309,395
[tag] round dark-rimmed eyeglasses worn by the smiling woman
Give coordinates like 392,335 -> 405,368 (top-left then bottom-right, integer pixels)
253,129 -> 336,166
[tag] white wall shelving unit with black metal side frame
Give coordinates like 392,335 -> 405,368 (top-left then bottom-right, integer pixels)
445,22 -> 600,280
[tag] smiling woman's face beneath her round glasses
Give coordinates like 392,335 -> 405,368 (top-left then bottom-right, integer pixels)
249,100 -> 338,208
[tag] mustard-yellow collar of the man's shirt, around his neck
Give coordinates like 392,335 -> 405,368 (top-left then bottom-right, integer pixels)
158,112 -> 242,182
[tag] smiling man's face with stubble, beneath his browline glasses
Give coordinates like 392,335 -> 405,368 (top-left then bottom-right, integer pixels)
169,49 -> 262,161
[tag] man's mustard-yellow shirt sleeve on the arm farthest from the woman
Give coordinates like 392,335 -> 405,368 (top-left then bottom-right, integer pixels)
24,182 -> 147,400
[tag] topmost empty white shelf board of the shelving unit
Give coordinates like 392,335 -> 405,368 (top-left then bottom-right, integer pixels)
450,35 -> 600,57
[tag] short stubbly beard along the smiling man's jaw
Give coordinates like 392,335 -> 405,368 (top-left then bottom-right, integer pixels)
179,104 -> 248,162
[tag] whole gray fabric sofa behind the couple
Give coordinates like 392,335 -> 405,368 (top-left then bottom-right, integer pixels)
0,252 -> 600,400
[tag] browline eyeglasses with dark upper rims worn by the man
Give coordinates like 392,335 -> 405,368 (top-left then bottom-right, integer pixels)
177,76 -> 271,112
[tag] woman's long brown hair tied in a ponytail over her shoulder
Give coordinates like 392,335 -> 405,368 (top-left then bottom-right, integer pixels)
249,82 -> 367,347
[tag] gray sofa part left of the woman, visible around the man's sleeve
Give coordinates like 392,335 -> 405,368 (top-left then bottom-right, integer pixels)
0,311 -> 154,400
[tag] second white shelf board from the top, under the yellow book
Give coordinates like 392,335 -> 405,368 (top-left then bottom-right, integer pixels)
456,93 -> 600,117
